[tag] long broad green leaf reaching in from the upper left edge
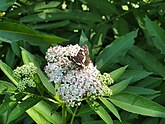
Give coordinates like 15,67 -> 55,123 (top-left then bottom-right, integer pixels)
0,22 -> 66,46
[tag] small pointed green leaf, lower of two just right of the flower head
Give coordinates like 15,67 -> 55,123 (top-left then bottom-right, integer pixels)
110,78 -> 132,95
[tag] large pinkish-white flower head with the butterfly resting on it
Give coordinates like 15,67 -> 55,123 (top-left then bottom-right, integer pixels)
45,44 -> 113,107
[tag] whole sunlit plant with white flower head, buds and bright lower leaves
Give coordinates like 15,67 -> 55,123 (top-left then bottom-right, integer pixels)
0,40 -> 165,124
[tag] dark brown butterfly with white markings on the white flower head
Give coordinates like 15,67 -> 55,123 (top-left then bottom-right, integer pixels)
68,45 -> 90,69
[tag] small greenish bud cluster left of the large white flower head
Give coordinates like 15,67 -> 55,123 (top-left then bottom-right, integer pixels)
14,62 -> 37,91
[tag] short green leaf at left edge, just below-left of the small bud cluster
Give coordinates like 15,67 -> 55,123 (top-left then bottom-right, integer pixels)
0,80 -> 16,94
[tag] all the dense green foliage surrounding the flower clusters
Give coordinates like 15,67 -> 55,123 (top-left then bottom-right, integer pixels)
0,0 -> 165,124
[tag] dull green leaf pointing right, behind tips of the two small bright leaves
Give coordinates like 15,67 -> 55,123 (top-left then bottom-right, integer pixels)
120,70 -> 152,84
